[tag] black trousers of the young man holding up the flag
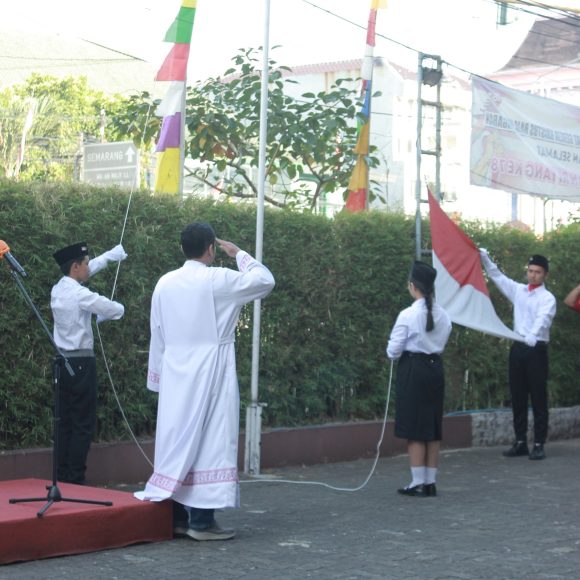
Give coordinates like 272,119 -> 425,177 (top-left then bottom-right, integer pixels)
509,342 -> 548,443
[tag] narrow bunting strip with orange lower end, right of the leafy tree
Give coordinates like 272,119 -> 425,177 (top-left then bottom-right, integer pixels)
345,0 -> 387,212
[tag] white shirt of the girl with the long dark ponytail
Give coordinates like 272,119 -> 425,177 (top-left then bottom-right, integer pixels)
387,298 -> 451,360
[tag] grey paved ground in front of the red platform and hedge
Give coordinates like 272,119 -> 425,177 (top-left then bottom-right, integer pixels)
0,440 -> 580,580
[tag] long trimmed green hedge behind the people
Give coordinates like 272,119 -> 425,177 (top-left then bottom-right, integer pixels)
0,183 -> 580,449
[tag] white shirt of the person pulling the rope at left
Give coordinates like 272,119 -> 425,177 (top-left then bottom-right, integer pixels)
50,258 -> 125,350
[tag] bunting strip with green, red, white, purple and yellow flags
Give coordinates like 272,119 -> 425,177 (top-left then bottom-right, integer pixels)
154,0 -> 197,193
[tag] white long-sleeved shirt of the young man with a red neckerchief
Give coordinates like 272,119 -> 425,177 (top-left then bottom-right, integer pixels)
483,257 -> 556,342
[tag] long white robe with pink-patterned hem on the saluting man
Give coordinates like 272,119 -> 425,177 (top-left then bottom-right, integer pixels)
135,251 -> 274,509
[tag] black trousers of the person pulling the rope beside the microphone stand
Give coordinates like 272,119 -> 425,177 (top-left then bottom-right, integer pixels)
57,356 -> 97,483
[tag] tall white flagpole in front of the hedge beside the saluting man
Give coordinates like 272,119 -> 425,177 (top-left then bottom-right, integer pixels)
244,0 -> 270,475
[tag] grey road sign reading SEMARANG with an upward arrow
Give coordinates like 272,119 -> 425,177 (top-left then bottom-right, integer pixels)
82,141 -> 139,189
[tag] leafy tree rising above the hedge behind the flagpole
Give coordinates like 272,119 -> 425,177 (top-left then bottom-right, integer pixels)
113,49 -> 379,210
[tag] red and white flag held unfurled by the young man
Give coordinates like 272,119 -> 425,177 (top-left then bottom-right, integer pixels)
429,192 -> 523,341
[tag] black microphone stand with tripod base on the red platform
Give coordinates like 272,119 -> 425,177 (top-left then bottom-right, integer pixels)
8,264 -> 113,518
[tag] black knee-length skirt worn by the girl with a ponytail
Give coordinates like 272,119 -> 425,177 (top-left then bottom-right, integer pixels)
395,351 -> 445,441
